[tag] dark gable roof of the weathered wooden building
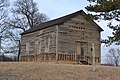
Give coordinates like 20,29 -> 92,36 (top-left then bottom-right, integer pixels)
21,10 -> 103,35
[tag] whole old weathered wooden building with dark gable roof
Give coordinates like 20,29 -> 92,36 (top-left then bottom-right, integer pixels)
21,10 -> 103,64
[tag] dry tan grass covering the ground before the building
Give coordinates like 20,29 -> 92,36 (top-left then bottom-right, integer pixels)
0,62 -> 120,80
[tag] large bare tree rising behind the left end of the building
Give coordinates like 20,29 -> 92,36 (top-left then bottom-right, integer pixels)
4,0 -> 49,59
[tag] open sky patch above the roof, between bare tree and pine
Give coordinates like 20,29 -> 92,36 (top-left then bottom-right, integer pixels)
35,0 -> 88,19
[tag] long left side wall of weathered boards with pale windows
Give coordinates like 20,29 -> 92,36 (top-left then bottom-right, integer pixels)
21,26 -> 56,56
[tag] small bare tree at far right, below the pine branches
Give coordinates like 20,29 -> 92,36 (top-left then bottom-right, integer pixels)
106,48 -> 120,66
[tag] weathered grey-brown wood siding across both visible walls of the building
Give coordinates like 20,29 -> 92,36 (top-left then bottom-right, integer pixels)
21,12 -> 100,62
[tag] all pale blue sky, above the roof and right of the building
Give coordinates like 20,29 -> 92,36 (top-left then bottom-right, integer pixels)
11,0 -> 118,62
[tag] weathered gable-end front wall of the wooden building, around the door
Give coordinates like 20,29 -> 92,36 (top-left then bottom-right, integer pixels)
58,15 -> 100,63
